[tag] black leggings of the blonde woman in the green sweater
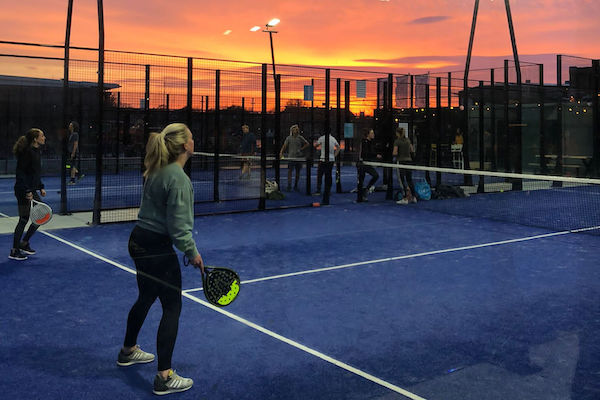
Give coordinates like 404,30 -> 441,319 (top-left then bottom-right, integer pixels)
123,226 -> 181,371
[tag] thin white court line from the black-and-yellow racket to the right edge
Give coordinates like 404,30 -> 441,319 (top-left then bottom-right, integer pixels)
185,226 -> 600,293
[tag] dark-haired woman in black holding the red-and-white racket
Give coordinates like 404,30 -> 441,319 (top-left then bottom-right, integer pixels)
8,128 -> 46,261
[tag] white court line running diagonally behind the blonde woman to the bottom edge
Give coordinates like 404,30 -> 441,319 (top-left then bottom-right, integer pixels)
35,231 -> 426,400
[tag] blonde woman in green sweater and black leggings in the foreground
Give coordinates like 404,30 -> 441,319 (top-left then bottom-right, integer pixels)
117,123 -> 204,395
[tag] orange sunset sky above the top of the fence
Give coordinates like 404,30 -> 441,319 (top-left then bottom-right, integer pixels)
0,0 -> 600,73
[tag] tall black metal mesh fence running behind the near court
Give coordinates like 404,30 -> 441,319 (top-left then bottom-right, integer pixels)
0,42 -> 599,222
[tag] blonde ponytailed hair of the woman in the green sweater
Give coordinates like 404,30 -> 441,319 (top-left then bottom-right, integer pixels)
144,123 -> 192,177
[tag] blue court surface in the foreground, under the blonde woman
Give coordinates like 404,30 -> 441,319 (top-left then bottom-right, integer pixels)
0,202 -> 600,400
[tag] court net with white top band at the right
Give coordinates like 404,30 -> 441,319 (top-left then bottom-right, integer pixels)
359,162 -> 600,234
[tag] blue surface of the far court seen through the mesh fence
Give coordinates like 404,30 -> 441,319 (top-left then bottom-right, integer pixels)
0,165 -> 360,216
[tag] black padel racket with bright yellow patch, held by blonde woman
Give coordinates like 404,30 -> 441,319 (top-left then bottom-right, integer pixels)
183,256 -> 240,307
